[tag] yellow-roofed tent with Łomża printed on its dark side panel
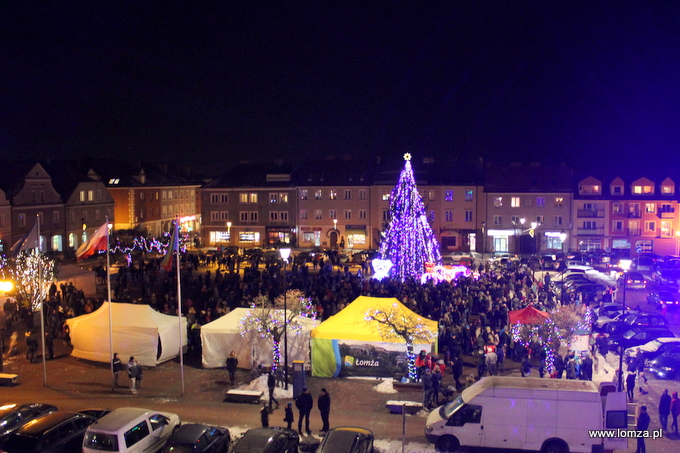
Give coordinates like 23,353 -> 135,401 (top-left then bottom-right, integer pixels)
311,296 -> 438,377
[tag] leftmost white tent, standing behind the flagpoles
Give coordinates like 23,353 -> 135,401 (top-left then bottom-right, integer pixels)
66,302 -> 187,366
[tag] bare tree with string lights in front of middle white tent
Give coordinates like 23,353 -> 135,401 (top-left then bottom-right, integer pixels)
239,289 -> 316,370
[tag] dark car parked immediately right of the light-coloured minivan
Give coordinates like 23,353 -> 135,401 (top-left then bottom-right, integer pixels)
163,423 -> 230,453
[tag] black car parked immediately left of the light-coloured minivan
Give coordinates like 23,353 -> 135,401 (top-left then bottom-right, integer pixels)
0,411 -> 97,453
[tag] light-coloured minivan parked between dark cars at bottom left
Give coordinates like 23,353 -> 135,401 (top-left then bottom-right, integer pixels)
83,407 -> 180,453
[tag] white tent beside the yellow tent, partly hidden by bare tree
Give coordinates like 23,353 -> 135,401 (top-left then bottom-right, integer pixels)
201,308 -> 319,368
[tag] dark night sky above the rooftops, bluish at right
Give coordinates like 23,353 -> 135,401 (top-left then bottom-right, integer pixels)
0,0 -> 680,169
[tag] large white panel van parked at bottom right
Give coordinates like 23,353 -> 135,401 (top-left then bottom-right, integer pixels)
425,376 -> 627,453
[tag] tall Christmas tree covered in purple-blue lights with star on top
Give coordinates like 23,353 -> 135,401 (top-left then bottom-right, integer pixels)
380,154 -> 441,280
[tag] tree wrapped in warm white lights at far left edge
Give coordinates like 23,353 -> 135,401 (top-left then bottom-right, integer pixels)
9,252 -> 54,310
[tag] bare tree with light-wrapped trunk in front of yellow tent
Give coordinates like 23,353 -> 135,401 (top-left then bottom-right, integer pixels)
365,304 -> 437,380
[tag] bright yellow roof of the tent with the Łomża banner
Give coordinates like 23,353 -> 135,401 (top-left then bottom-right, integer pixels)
312,296 -> 438,343
